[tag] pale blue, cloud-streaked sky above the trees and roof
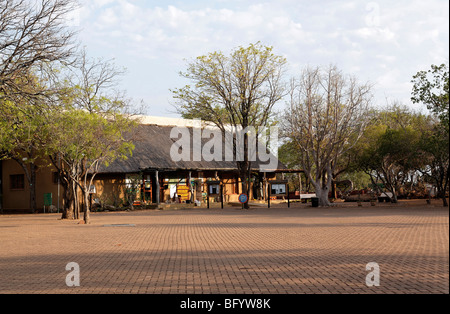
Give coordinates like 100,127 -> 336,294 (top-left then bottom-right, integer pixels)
69,0 -> 449,117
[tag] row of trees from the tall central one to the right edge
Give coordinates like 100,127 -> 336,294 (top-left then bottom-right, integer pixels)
173,43 -> 449,206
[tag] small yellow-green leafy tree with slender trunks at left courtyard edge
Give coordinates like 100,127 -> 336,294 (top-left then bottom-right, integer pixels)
47,109 -> 134,223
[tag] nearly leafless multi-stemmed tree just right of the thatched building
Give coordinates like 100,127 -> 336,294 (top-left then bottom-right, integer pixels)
283,66 -> 371,206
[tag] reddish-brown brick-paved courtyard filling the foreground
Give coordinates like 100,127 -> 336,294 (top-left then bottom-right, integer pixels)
0,204 -> 449,294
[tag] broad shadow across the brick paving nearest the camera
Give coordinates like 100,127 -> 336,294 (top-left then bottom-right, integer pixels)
0,249 -> 449,293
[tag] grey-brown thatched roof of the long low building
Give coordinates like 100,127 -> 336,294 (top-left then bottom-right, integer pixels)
100,124 -> 286,173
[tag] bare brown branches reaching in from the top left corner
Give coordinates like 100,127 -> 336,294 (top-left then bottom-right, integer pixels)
0,0 -> 77,100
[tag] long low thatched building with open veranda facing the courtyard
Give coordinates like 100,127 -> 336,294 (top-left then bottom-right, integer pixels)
92,117 -> 290,204
